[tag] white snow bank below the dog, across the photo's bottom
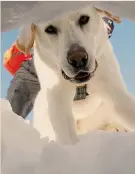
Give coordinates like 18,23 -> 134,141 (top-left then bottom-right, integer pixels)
1,99 -> 135,174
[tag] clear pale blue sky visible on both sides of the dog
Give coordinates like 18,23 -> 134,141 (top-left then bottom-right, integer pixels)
1,20 -> 135,117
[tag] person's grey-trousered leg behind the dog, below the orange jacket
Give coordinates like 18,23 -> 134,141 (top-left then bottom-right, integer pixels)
7,60 -> 40,118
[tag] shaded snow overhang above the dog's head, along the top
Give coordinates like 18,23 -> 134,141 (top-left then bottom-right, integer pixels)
1,1 -> 135,31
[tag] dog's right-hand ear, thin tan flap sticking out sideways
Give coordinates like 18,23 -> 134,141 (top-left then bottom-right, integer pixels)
96,8 -> 121,24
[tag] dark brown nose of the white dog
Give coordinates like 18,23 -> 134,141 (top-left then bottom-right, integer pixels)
67,44 -> 88,69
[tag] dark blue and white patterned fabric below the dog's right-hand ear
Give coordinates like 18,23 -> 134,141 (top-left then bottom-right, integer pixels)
103,16 -> 114,38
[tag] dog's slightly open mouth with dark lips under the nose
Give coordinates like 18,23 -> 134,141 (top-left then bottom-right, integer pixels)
62,62 -> 98,83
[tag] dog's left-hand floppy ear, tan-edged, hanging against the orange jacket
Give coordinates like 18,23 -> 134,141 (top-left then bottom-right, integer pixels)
16,24 -> 35,54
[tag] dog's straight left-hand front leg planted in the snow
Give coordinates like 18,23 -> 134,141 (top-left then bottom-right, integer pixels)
47,84 -> 77,144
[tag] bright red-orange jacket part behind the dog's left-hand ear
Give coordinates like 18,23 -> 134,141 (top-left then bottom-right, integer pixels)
4,43 -> 32,75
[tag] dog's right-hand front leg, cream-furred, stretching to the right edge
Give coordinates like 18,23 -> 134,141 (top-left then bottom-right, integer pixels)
101,80 -> 135,131
